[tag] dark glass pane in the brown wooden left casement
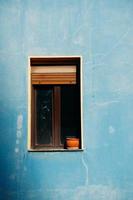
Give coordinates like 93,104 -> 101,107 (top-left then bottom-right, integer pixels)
36,86 -> 53,144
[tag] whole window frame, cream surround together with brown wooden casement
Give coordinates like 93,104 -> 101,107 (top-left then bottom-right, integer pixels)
28,56 -> 83,151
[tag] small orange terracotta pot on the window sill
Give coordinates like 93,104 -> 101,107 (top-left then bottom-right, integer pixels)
66,137 -> 79,149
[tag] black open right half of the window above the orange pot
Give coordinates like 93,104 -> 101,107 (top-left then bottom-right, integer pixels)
61,85 -> 81,144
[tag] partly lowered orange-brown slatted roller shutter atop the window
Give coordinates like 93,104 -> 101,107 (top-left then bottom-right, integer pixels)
31,65 -> 76,84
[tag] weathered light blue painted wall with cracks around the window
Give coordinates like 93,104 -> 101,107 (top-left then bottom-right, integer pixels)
0,0 -> 133,200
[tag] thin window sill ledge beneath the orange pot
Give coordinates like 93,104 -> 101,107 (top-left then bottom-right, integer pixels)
28,149 -> 84,152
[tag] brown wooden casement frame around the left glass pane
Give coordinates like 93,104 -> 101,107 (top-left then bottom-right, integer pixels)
31,86 -> 63,149
